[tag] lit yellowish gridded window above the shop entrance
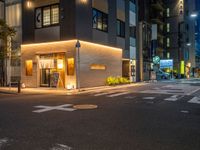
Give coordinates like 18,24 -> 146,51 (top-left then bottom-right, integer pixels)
35,4 -> 60,28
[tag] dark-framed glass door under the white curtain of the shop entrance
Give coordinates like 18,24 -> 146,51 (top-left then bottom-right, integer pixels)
40,69 -> 50,87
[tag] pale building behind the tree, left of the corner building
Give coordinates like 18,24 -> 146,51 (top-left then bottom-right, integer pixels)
5,0 -> 22,84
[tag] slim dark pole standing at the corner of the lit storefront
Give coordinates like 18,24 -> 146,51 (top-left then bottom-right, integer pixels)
76,40 -> 81,91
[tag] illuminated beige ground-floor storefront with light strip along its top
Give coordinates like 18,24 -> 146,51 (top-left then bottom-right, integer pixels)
21,40 -> 122,89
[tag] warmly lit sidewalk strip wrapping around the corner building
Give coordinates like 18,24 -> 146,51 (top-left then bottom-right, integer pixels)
0,82 -> 147,95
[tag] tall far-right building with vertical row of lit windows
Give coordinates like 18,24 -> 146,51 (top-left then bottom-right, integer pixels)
164,0 -> 195,77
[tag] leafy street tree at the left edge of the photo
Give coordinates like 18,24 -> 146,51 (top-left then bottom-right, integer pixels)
0,19 -> 16,85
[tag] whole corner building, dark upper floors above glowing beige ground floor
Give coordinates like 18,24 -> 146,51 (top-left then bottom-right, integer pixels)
21,0 -> 138,88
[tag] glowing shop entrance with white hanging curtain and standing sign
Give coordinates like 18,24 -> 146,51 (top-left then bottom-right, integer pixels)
39,53 -> 65,88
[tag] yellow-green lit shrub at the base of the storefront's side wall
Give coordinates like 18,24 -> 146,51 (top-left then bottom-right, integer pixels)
106,76 -> 131,85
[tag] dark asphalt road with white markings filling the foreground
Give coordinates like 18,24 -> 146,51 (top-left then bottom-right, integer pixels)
0,83 -> 200,150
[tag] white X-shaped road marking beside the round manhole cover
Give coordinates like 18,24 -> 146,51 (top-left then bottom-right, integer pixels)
33,104 -> 76,113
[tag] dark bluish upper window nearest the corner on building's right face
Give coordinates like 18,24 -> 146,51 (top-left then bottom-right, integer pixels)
92,9 -> 108,32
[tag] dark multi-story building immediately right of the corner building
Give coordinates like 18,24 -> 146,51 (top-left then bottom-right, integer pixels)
138,0 -> 165,80
